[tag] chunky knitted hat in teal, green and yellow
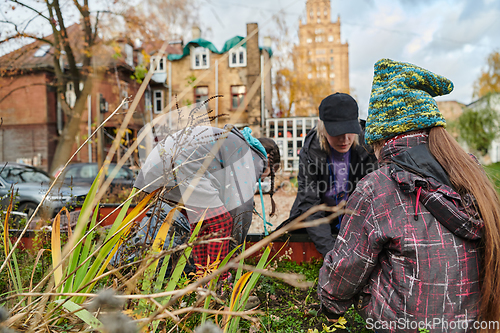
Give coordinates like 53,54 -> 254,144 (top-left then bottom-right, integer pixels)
365,59 -> 453,144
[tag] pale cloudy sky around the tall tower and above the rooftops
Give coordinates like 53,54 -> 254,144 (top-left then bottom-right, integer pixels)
195,0 -> 500,117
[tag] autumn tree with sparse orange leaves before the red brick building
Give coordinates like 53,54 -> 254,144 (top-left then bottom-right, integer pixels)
0,0 -> 199,170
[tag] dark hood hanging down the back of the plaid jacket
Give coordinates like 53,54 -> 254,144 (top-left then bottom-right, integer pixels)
381,138 -> 484,240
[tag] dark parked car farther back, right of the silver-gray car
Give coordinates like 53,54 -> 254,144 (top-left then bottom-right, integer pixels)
54,163 -> 135,188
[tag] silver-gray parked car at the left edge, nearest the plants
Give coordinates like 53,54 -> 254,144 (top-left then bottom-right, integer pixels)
0,162 -> 89,222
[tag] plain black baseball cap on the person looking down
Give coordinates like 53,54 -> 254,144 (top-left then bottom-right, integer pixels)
319,93 -> 361,136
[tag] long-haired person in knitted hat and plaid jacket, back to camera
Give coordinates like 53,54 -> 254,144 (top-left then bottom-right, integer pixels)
318,59 -> 500,332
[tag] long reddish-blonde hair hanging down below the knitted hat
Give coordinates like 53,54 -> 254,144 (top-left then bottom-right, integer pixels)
429,127 -> 500,331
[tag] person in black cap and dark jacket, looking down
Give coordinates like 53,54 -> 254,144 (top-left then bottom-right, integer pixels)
284,93 -> 377,257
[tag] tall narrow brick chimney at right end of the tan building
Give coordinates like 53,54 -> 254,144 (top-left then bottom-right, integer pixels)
246,23 -> 261,137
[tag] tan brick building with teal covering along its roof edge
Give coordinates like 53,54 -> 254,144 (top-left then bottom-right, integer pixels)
150,23 -> 272,136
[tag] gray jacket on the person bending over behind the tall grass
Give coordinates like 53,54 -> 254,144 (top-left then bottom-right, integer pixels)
134,126 -> 267,243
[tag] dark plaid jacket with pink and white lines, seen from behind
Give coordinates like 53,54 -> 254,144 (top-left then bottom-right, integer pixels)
318,136 -> 483,332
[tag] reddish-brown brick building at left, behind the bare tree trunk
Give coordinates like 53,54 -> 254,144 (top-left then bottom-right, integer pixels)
0,24 -> 147,170
